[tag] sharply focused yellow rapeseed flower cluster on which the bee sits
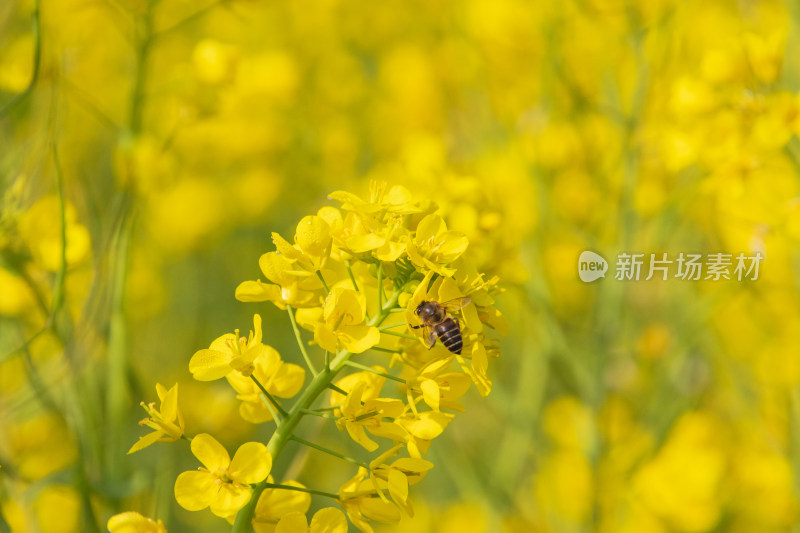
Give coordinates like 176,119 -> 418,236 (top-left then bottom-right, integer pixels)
118,183 -> 505,532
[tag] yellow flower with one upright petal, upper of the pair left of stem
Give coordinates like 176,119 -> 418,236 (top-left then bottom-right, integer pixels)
189,314 -> 269,381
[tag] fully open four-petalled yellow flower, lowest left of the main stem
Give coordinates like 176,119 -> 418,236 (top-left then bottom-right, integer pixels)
175,433 -> 272,518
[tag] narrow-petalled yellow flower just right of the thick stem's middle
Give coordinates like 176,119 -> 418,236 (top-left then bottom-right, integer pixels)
336,381 -> 405,452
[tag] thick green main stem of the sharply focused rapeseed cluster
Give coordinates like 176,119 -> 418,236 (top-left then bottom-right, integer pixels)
231,290 -> 400,533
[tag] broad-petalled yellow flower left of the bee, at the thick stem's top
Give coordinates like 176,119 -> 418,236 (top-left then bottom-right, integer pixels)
314,287 -> 381,353
